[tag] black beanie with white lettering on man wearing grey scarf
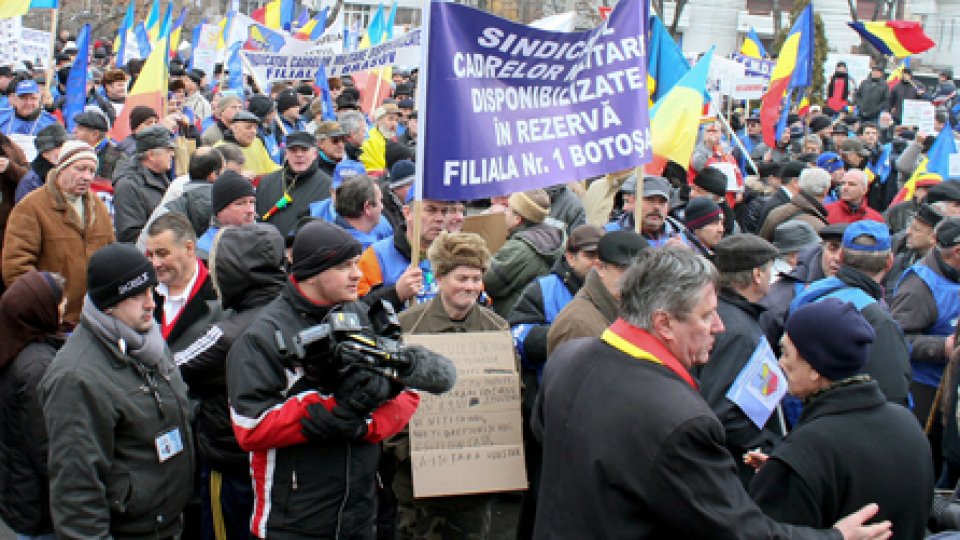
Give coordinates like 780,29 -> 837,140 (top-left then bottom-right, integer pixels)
87,243 -> 157,311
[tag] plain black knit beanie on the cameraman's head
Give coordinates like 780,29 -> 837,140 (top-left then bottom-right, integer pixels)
290,220 -> 362,279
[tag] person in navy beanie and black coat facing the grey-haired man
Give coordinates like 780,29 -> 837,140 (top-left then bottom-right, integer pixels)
748,298 -> 933,539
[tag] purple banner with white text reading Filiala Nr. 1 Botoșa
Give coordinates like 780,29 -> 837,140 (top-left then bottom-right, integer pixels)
417,0 -> 651,200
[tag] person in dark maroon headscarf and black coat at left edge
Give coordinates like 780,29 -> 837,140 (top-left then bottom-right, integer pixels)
0,271 -> 64,539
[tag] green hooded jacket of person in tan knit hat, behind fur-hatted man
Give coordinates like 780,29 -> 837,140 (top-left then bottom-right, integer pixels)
483,223 -> 567,318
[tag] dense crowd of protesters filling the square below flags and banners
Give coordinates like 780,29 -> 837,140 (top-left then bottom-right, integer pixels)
0,23 -> 960,540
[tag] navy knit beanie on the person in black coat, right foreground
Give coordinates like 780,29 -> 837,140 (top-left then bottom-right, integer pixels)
786,298 -> 876,381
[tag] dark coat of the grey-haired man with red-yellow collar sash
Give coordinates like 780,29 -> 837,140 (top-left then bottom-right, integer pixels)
531,332 -> 840,540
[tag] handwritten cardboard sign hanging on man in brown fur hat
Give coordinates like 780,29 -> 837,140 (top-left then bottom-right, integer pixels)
404,332 -> 527,498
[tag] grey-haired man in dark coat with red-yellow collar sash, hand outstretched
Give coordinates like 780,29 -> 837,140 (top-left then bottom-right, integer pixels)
531,246 -> 890,539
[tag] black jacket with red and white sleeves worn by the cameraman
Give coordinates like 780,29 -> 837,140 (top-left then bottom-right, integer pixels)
227,280 -> 419,540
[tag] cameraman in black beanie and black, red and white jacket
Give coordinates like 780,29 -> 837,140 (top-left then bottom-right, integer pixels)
227,221 -> 426,540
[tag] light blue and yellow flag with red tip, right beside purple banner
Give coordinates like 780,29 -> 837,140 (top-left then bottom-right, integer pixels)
644,48 -> 713,175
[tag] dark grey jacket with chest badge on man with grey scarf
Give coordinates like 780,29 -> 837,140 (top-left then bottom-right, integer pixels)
40,318 -> 196,540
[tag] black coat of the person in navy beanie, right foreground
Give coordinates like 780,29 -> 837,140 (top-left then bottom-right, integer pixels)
750,381 -> 934,540
